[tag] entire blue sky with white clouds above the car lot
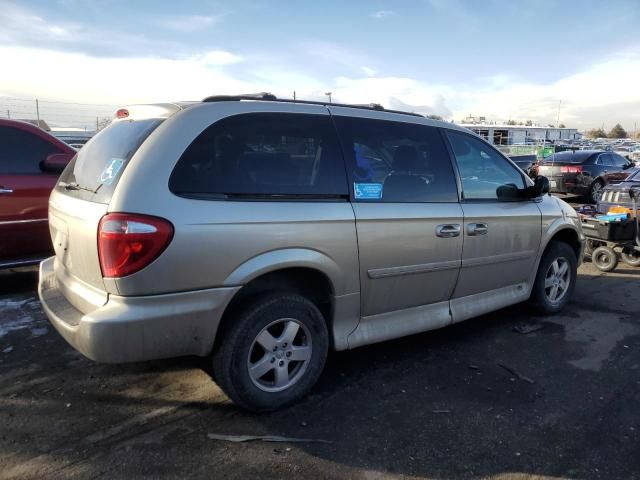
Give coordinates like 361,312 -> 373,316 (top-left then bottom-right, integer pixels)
0,0 -> 640,130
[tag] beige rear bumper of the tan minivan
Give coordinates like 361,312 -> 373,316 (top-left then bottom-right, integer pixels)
38,257 -> 240,363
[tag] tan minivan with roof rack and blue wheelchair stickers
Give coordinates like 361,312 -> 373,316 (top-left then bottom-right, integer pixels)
39,95 -> 583,410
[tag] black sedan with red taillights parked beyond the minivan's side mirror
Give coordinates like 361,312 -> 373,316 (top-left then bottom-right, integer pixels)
538,150 -> 634,203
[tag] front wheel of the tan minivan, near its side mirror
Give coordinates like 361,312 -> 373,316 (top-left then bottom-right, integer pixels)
531,242 -> 578,314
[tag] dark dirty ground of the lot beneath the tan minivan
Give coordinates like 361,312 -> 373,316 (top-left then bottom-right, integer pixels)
0,256 -> 640,479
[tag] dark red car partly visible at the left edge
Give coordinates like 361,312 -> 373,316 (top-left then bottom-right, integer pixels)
0,119 -> 75,268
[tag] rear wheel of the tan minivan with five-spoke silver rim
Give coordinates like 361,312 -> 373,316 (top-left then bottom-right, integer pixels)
212,294 -> 329,412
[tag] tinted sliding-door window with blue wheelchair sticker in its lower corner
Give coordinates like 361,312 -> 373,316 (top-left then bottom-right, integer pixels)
334,116 -> 458,202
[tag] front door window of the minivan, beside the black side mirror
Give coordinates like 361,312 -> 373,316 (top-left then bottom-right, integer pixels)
447,130 -> 525,200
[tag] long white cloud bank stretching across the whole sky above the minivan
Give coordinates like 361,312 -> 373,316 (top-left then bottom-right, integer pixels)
0,43 -> 640,130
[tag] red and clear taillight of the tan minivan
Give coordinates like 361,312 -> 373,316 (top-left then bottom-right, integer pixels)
98,213 -> 173,277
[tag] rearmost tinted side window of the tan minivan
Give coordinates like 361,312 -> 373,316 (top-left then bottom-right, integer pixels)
169,113 -> 348,199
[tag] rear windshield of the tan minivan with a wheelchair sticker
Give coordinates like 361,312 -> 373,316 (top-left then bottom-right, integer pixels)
56,118 -> 163,203
